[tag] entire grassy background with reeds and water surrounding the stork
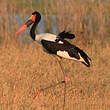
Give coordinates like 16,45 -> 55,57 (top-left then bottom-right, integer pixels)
0,0 -> 110,110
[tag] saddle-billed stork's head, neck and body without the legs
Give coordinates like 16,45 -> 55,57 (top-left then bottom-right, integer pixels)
16,11 -> 91,83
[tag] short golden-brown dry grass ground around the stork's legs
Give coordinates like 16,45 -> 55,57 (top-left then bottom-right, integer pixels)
0,39 -> 110,110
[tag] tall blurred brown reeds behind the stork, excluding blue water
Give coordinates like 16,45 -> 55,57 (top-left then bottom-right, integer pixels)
0,0 -> 110,44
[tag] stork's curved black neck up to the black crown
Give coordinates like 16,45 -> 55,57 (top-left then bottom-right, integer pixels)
30,11 -> 41,40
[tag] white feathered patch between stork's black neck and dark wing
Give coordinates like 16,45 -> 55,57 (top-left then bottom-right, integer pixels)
35,33 -> 57,42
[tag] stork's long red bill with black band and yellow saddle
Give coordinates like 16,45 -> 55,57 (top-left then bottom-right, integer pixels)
16,15 -> 36,36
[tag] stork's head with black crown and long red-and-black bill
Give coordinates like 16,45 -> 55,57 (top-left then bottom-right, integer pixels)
16,11 -> 41,36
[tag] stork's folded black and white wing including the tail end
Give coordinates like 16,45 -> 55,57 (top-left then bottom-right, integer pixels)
41,40 -> 91,67
